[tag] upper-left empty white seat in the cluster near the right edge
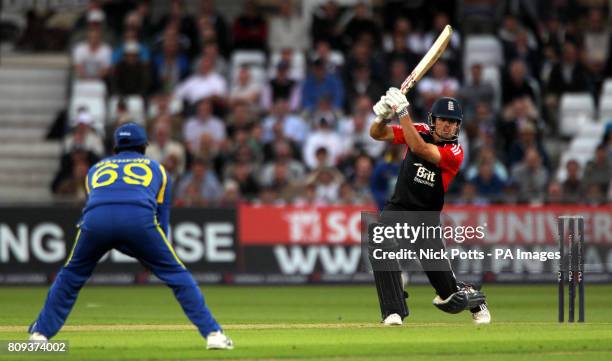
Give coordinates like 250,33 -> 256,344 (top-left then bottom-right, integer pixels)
559,93 -> 595,136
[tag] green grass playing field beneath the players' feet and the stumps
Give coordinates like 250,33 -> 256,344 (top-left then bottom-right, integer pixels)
0,284 -> 612,361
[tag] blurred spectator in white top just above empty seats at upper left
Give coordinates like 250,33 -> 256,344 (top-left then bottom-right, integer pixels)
72,27 -> 112,80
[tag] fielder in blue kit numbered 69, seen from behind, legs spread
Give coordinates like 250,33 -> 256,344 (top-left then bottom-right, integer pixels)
29,123 -> 233,349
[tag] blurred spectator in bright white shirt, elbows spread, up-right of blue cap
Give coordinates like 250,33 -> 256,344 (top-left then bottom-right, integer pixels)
174,56 -> 227,105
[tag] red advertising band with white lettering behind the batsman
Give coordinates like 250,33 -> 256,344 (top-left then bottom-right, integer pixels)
238,205 -> 612,246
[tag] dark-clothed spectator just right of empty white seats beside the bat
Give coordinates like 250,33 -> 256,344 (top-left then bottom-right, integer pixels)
502,59 -> 539,108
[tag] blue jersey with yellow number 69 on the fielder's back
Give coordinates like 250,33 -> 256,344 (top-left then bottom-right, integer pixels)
83,151 -> 171,235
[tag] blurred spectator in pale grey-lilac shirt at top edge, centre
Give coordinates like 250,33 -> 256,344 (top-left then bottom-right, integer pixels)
268,0 -> 309,52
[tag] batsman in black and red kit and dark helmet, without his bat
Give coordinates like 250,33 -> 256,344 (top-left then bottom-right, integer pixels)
369,88 -> 491,325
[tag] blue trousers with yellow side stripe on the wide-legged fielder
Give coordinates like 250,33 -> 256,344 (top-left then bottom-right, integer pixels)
29,205 -> 221,338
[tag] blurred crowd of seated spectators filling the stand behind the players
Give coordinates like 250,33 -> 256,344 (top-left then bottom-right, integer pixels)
44,0 -> 612,206
